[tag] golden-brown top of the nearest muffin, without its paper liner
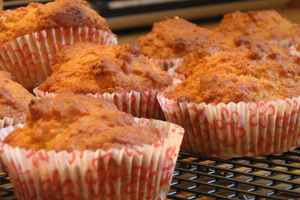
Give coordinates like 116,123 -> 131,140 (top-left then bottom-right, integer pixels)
4,94 -> 158,152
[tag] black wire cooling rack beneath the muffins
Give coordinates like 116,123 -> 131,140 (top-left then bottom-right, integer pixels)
0,148 -> 300,200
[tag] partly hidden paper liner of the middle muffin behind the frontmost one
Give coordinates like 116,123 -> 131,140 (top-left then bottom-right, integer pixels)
33,88 -> 165,120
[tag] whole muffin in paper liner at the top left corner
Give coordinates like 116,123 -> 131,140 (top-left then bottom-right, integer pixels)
0,0 -> 116,89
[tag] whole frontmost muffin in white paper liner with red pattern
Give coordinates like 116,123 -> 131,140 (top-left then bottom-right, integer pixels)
0,94 -> 183,199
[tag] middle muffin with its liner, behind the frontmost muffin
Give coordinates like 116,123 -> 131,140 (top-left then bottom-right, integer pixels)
34,43 -> 172,119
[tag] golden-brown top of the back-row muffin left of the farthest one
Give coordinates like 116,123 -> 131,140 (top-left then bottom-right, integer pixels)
137,18 -> 213,59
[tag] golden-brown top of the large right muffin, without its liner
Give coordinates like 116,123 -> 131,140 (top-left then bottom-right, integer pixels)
169,36 -> 300,104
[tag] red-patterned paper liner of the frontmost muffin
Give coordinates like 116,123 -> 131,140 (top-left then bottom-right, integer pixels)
0,119 -> 184,200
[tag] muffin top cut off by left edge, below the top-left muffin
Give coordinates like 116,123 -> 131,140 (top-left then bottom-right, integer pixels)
0,71 -> 35,119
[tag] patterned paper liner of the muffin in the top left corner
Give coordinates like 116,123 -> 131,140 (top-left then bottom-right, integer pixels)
0,27 -> 117,89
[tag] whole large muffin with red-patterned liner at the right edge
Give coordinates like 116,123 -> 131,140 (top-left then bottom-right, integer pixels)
158,36 -> 300,157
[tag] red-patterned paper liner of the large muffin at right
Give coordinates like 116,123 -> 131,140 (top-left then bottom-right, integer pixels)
158,87 -> 300,157
